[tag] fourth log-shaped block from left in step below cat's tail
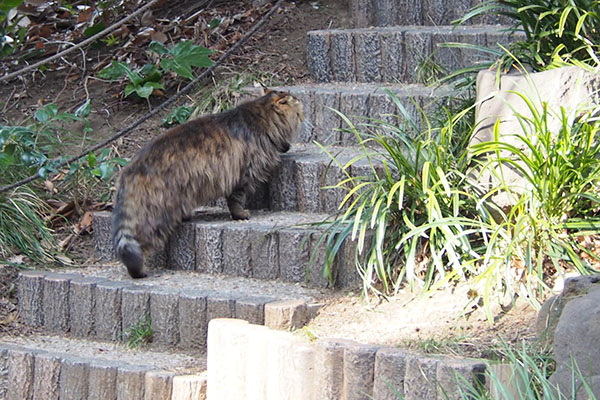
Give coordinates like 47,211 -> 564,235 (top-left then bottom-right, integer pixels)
94,281 -> 130,340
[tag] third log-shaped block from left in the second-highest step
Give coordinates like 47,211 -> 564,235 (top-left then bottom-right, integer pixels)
354,30 -> 381,83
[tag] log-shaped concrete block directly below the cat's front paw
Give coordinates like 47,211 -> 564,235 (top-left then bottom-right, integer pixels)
223,225 -> 252,278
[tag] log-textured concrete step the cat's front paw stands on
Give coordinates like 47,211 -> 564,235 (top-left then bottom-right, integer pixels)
93,209 -> 360,288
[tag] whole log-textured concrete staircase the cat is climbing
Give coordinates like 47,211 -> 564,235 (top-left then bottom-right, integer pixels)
0,0 -> 511,400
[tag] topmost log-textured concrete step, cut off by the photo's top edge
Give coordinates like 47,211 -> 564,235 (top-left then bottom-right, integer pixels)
350,0 -> 512,27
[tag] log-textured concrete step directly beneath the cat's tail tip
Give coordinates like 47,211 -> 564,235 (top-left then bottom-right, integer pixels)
18,267 -> 324,351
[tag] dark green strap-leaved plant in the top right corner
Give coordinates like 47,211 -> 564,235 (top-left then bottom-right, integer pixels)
456,0 -> 600,70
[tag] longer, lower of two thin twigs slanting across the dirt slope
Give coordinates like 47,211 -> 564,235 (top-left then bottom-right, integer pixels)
0,0 -> 283,193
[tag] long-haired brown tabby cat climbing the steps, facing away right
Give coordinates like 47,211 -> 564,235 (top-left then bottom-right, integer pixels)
113,91 -> 304,278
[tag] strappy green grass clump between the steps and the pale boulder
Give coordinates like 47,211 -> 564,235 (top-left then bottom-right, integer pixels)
316,93 -> 490,293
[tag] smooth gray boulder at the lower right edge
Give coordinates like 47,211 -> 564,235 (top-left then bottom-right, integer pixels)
536,275 -> 600,400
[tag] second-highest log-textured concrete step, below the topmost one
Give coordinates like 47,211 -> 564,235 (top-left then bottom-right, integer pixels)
307,25 -> 515,83
